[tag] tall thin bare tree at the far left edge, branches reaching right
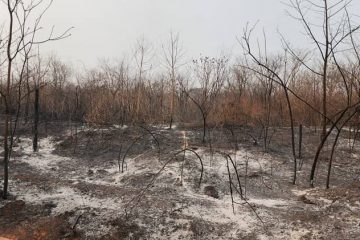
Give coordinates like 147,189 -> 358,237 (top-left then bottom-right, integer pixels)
1,0 -> 69,199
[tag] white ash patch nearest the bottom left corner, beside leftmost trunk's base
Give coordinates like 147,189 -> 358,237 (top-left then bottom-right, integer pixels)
12,181 -> 123,238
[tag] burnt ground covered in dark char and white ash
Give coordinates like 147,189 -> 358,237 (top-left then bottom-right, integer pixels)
0,126 -> 360,239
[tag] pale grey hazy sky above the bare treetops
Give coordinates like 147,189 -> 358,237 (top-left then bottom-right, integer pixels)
0,0 -> 360,66
